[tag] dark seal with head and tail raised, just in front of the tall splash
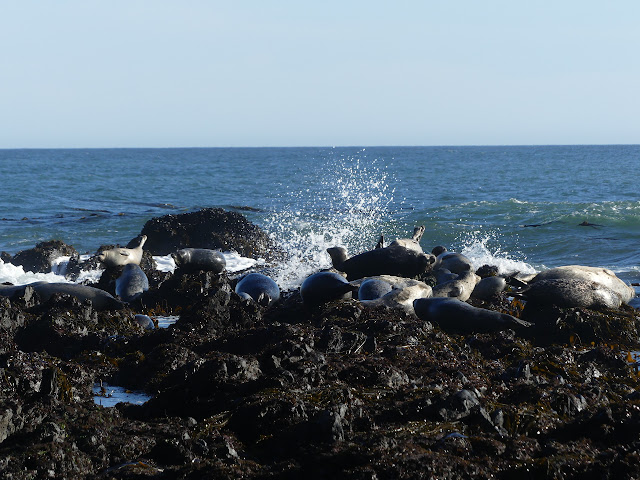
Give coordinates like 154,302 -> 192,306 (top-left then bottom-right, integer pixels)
327,227 -> 435,280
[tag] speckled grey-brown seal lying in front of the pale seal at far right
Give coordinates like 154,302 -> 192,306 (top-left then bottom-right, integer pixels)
513,278 -> 622,309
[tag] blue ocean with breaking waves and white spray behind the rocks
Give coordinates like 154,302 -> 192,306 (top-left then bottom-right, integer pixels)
0,145 -> 640,289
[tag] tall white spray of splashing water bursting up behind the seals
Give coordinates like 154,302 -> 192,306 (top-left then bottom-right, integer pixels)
266,150 -> 395,290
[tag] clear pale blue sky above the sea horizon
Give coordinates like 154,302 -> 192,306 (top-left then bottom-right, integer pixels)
0,0 -> 640,148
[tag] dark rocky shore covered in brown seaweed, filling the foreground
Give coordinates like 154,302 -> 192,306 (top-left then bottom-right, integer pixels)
0,209 -> 640,480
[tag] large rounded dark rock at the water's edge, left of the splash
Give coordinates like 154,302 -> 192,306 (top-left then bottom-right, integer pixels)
141,208 -> 274,258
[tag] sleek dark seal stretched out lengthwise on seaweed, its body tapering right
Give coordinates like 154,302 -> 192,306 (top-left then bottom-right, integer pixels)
413,298 -> 533,334
